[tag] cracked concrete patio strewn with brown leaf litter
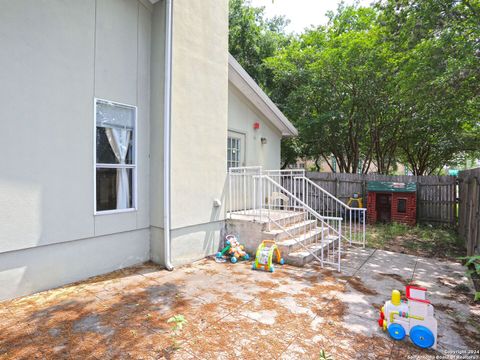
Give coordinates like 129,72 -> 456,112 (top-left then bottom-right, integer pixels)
0,248 -> 480,359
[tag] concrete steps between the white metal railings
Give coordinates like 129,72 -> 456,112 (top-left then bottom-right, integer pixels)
262,212 -> 338,266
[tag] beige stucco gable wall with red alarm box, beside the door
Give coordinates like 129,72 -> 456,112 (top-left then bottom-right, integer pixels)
228,84 -> 282,170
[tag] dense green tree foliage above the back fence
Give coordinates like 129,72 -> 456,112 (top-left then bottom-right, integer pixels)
229,0 -> 480,175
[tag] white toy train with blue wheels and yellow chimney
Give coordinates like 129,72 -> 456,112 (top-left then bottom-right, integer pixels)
378,285 -> 437,349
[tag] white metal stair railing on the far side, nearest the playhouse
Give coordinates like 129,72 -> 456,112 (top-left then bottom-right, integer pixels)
294,176 -> 367,247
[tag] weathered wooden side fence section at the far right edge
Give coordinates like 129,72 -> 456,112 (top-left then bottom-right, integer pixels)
458,168 -> 480,255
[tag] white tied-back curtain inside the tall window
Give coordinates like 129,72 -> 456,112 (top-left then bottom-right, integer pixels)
105,128 -> 132,209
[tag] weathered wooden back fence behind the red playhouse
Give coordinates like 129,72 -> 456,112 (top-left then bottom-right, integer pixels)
306,172 -> 457,226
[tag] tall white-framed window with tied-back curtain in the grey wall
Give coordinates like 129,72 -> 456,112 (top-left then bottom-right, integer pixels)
95,99 -> 137,214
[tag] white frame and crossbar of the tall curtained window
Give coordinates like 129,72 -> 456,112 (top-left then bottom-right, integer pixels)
93,97 -> 138,215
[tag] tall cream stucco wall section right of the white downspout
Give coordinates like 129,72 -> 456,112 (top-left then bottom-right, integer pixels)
163,0 -> 228,265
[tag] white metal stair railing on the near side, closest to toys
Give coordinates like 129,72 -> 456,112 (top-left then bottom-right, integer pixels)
252,175 -> 343,271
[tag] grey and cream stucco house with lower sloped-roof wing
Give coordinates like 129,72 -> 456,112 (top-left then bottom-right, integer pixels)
0,0 -> 297,300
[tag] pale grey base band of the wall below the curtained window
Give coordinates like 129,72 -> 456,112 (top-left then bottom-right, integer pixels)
0,229 -> 150,301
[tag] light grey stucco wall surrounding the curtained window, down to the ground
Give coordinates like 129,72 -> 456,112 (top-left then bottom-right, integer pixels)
0,0 -> 151,299
